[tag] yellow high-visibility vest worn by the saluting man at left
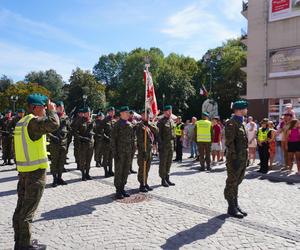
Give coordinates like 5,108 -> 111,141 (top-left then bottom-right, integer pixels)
14,114 -> 49,172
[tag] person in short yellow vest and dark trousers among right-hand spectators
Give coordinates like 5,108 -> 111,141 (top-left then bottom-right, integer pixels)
257,118 -> 270,174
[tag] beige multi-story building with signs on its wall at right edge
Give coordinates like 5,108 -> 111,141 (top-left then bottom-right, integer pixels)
242,0 -> 300,120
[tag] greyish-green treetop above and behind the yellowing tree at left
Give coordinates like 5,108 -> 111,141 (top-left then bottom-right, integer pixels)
25,69 -> 64,100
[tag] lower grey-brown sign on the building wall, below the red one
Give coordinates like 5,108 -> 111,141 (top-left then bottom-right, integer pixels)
269,47 -> 300,78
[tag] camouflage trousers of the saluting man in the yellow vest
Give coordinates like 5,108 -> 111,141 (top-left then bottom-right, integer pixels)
13,169 -> 46,246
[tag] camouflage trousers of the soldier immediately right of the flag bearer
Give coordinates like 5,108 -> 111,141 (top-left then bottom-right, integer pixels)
159,145 -> 173,179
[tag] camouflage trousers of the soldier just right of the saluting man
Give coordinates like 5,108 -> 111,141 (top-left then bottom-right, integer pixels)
49,144 -> 67,175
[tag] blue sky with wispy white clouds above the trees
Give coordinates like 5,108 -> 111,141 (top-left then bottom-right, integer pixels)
0,0 -> 246,81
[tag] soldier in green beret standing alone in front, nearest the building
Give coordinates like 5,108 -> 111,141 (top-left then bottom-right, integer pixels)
224,101 -> 248,218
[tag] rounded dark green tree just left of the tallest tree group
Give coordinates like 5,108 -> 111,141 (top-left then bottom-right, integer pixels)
66,68 -> 106,111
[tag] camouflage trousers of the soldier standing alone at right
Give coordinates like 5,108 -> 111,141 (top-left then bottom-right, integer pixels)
224,157 -> 247,201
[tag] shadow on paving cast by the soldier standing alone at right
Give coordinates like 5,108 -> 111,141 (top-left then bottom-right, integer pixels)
161,214 -> 229,250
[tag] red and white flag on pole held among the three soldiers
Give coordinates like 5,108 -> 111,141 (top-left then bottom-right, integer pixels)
144,69 -> 158,117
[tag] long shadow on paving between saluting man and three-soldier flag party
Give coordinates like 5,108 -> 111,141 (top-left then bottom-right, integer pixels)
35,194 -> 114,222
